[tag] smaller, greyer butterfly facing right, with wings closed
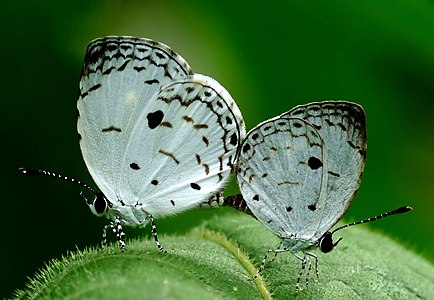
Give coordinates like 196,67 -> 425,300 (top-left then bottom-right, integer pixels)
225,101 -> 411,294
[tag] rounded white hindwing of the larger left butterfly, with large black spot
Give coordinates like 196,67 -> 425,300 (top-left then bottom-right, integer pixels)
116,74 -> 245,216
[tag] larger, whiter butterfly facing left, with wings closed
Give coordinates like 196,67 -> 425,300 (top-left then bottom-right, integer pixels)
21,36 -> 245,251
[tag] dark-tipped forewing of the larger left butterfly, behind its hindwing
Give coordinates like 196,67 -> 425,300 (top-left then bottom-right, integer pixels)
77,37 -> 192,202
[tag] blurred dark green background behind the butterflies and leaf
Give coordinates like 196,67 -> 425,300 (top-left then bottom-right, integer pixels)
0,0 -> 434,298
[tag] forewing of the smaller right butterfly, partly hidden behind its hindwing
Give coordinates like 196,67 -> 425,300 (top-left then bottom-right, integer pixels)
282,101 -> 367,240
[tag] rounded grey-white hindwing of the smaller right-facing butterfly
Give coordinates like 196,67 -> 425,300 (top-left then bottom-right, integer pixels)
237,117 -> 325,239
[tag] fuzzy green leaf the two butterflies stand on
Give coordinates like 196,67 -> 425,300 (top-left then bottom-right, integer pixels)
15,212 -> 434,299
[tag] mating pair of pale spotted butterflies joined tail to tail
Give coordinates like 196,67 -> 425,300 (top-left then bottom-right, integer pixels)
20,36 -> 411,289
